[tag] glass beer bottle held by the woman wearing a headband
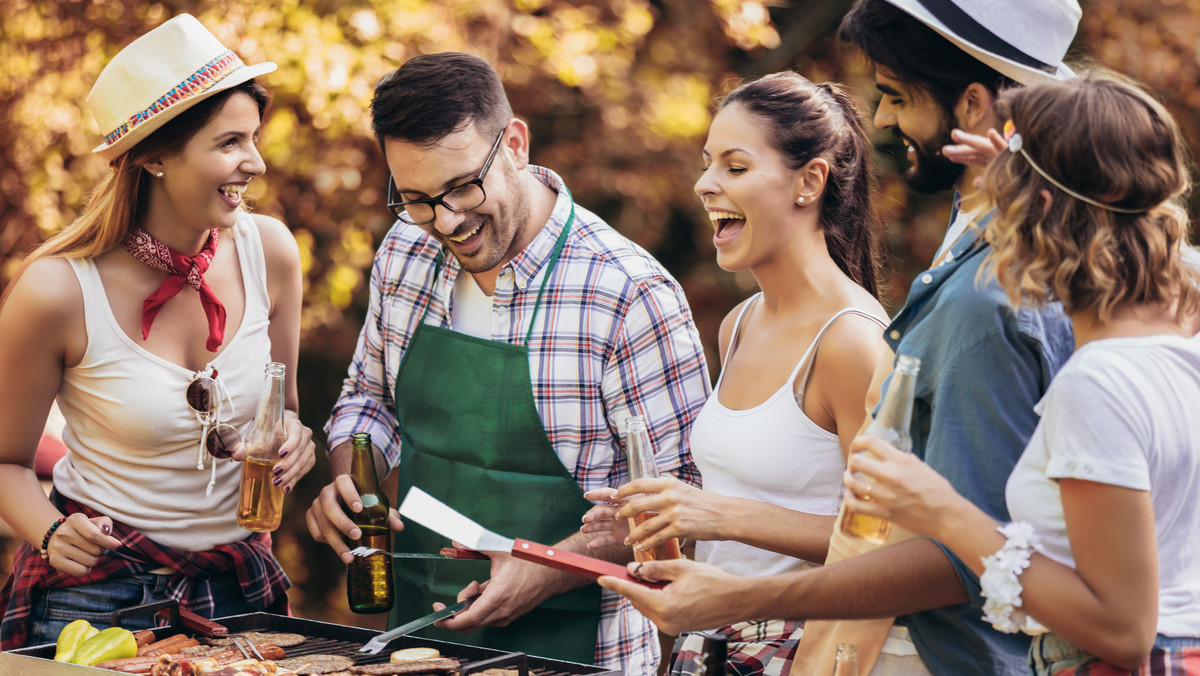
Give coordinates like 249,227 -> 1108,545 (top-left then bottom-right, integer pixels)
841,354 -> 920,544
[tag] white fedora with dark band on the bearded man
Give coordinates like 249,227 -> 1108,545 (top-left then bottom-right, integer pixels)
887,0 -> 1084,84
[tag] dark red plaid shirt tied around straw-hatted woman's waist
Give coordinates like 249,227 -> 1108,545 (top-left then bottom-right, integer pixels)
0,493 -> 292,651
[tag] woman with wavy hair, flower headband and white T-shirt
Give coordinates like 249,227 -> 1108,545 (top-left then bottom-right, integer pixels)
845,74 -> 1200,675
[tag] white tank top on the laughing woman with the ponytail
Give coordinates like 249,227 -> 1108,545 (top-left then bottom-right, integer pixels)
691,294 -> 884,576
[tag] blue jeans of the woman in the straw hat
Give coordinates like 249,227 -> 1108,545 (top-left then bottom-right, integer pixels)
25,573 -> 264,646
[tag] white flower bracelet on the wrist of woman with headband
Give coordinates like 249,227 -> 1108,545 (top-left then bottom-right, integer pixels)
979,521 -> 1046,634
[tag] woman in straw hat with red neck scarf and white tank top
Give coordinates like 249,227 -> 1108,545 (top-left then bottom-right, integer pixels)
0,14 -> 313,650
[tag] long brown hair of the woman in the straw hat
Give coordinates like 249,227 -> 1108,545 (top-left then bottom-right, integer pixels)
5,79 -> 270,298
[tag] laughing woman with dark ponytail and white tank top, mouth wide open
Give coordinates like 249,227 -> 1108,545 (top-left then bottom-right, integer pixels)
583,72 -> 887,675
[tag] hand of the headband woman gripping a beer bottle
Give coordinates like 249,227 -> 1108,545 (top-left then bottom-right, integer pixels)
842,436 -> 973,539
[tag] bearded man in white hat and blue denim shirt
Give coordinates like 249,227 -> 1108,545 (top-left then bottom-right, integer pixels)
601,0 -> 1081,676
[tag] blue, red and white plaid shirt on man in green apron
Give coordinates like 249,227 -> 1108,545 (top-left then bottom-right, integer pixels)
325,167 -> 709,674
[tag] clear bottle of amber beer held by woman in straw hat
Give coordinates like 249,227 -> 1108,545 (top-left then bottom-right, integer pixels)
238,361 -> 287,532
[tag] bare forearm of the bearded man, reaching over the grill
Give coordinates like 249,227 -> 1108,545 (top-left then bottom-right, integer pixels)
722,539 -> 967,620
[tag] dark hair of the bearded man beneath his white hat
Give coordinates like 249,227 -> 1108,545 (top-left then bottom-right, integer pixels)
838,0 -> 1018,112
